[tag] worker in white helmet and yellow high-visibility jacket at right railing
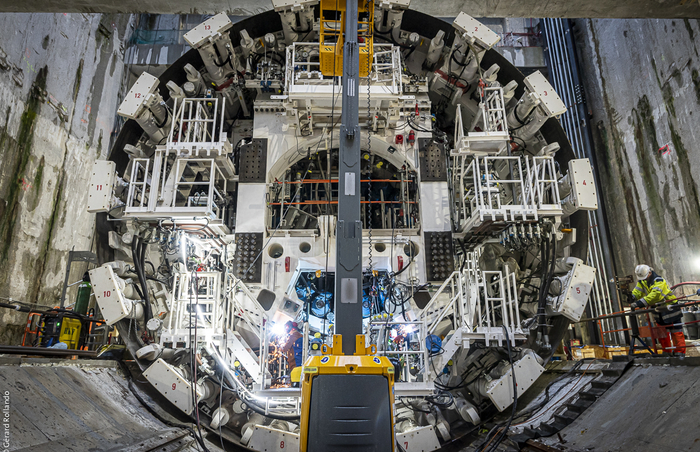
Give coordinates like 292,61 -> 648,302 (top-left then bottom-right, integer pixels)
631,264 -> 685,355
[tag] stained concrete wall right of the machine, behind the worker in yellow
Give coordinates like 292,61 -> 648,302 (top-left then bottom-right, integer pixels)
575,19 -> 700,283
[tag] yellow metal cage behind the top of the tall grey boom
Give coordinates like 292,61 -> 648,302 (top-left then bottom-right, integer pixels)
319,0 -> 374,77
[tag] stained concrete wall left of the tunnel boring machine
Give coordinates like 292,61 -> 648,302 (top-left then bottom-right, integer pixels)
0,14 -> 131,344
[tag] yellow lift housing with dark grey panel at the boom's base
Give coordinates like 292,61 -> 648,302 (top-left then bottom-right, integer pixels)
300,335 -> 395,452
